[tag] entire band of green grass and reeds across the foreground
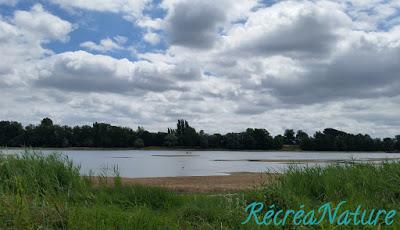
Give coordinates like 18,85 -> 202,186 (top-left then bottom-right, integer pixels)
0,153 -> 400,229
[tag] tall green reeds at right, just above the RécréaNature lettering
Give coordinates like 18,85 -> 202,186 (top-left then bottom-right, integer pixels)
246,162 -> 400,229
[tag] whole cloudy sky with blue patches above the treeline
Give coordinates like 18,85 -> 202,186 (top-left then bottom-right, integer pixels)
0,0 -> 400,137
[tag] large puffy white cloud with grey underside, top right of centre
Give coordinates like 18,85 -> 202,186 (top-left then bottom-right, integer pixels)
226,1 -> 351,58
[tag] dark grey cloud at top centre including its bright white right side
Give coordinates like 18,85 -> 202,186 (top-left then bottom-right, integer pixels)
163,0 -> 257,49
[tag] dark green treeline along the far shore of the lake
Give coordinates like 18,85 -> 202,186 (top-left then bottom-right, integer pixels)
0,118 -> 400,152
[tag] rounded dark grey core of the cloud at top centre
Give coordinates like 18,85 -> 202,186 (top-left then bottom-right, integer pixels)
166,1 -> 226,49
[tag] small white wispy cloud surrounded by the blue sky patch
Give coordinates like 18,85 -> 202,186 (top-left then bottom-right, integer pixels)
80,36 -> 127,53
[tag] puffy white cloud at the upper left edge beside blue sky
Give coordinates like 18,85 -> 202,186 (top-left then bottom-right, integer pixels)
0,4 -> 73,86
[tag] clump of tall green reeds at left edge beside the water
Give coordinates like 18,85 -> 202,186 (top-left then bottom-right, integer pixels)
0,152 -> 86,197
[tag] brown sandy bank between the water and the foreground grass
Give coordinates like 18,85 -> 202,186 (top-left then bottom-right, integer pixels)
92,173 -> 276,193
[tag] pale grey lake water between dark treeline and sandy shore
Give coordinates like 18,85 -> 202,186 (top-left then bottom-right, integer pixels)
2,149 -> 400,177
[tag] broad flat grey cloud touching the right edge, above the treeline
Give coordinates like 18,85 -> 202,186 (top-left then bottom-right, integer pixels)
263,45 -> 400,104
